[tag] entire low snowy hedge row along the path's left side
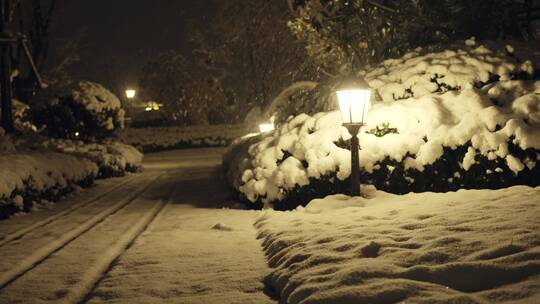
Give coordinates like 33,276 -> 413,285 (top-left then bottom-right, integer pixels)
0,128 -> 143,219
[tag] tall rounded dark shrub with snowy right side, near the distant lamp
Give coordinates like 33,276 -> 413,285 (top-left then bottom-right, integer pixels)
31,81 -> 124,139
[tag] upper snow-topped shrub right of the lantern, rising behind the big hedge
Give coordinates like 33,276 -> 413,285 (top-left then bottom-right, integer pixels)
365,40 -> 537,101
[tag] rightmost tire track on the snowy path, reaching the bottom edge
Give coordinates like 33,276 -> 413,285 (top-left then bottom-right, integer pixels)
59,190 -> 170,304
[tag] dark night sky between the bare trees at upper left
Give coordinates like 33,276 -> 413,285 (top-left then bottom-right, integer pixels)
49,0 -> 212,94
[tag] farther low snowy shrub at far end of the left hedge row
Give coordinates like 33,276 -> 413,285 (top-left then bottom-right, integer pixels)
42,139 -> 143,178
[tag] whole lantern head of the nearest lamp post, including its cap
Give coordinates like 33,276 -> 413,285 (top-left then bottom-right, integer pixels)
336,76 -> 371,125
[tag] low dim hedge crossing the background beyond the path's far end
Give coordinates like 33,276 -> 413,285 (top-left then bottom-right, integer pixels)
118,125 -> 249,152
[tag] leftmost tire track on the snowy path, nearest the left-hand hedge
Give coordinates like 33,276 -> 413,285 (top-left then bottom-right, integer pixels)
0,176 -> 136,247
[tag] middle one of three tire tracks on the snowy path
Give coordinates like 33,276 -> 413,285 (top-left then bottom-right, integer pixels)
0,174 -> 163,290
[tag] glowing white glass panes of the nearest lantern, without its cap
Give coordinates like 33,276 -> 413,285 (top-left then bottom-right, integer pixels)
336,89 -> 371,124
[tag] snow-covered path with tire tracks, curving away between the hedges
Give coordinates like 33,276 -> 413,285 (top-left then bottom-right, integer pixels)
0,149 -> 274,303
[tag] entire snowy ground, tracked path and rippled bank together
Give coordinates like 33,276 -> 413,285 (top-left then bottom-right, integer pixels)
0,149 -> 540,304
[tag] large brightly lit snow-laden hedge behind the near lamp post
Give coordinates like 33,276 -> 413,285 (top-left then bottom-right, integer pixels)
225,40 -> 540,209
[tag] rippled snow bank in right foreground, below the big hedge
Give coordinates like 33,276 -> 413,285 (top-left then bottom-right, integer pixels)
256,186 -> 540,304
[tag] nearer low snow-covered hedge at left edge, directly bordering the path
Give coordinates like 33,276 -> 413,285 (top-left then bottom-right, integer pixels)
0,150 -> 98,219
